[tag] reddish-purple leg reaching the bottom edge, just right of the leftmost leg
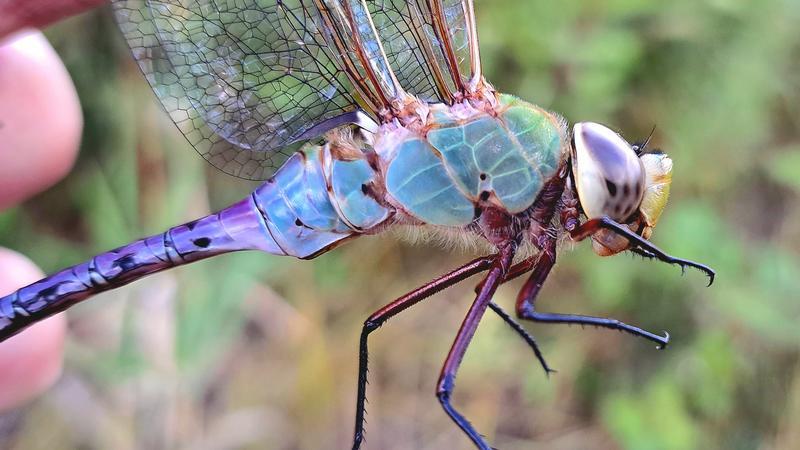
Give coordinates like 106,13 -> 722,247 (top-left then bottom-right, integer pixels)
436,246 -> 514,450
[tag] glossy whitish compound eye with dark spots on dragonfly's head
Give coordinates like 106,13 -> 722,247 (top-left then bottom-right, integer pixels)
572,122 -> 645,222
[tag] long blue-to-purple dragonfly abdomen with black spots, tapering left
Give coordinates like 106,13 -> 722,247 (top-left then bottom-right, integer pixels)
0,147 -> 390,341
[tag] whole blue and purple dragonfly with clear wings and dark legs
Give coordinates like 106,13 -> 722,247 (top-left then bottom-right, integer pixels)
0,0 -> 715,449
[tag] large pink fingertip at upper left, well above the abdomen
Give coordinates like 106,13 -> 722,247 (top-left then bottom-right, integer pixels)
0,31 -> 83,209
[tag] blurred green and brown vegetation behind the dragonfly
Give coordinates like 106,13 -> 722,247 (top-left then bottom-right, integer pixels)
0,0 -> 800,450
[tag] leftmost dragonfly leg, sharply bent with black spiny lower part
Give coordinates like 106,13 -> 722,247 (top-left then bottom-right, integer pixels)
353,256 -> 496,450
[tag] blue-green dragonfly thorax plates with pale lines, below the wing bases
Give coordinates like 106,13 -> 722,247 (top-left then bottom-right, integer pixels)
375,95 -> 566,227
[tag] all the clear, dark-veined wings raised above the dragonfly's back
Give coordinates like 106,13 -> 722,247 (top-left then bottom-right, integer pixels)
112,0 -> 480,179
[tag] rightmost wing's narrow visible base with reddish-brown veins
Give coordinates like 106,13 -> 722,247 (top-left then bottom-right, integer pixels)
366,0 -> 481,103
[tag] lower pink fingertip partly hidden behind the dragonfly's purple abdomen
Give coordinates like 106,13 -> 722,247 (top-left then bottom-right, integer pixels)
0,248 -> 66,411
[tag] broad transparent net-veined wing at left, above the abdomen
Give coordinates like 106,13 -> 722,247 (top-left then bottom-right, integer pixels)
113,0 -> 359,180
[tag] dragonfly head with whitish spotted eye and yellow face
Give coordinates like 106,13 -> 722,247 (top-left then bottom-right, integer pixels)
571,122 -> 672,256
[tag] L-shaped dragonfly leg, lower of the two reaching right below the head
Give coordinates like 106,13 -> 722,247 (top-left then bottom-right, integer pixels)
516,239 -> 669,348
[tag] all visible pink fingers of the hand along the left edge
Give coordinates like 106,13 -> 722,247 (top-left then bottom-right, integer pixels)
0,0 -> 104,411
